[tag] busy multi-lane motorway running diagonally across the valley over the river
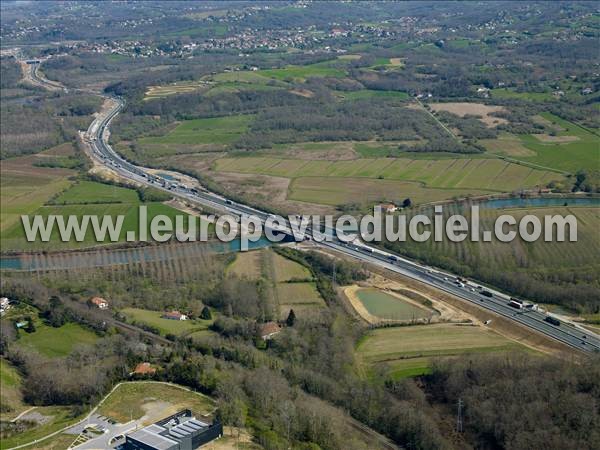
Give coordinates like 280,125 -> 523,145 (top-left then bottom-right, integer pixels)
77,89 -> 600,353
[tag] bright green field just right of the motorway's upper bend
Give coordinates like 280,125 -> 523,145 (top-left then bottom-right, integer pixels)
139,115 -> 254,145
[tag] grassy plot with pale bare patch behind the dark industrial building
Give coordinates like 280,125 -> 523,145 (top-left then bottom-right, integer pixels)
98,381 -> 215,425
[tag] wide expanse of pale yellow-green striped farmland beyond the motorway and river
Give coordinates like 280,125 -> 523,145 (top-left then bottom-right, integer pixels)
214,153 -> 562,205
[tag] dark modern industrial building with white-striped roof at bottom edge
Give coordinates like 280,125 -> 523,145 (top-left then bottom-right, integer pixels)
124,409 -> 223,450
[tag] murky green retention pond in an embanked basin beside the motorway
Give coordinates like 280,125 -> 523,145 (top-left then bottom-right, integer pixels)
356,288 -> 433,320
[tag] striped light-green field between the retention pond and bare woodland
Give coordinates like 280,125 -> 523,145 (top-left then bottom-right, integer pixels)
356,324 -> 522,378
